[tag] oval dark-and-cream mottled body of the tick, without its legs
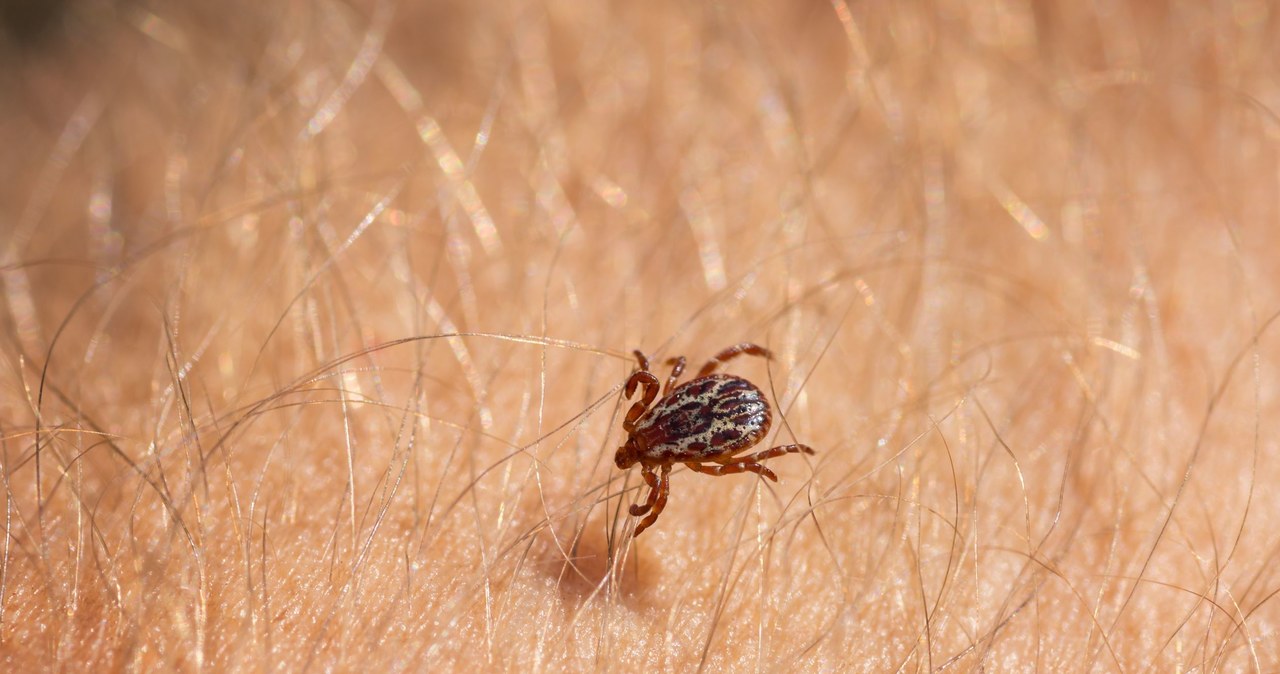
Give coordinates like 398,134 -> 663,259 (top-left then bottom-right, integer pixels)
632,375 -> 773,463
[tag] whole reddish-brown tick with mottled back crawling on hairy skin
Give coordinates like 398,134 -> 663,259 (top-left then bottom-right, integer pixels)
613,344 -> 813,536
